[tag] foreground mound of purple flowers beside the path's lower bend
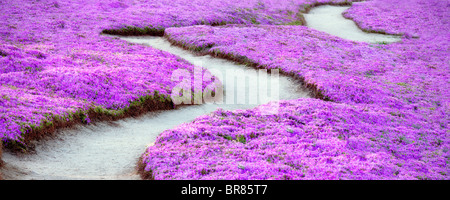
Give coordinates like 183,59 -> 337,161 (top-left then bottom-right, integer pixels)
143,99 -> 450,179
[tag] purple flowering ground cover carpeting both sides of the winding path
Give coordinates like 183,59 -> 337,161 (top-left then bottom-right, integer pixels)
0,0 -> 450,179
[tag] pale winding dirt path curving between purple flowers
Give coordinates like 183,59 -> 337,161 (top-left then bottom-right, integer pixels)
2,6 -> 399,180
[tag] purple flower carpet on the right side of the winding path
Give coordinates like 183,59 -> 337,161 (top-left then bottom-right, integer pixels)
142,0 -> 450,179
